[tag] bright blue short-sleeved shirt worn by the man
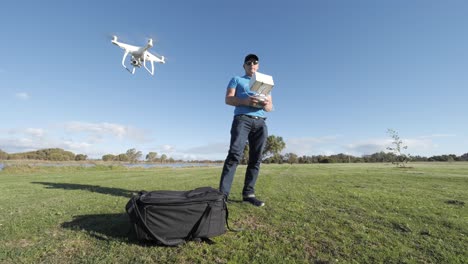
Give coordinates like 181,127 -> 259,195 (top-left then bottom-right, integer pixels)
227,75 -> 265,117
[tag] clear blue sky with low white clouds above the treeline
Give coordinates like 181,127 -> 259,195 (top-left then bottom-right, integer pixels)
0,0 -> 468,160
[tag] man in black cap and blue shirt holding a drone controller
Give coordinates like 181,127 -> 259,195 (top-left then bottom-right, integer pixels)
219,54 -> 273,207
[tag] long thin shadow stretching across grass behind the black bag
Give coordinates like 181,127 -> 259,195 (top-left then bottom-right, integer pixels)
32,182 -> 137,198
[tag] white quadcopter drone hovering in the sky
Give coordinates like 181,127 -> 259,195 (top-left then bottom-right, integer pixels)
112,36 -> 166,75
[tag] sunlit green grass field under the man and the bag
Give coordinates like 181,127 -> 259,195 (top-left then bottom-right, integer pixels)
0,162 -> 468,263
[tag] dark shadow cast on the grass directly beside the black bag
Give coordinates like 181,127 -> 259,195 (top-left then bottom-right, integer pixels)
61,214 -> 139,244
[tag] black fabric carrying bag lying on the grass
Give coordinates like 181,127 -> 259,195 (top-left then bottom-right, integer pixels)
125,187 -> 228,246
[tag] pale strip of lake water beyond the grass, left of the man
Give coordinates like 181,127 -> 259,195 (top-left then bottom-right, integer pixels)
0,163 -> 222,171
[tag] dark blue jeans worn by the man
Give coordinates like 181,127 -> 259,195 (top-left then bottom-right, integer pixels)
219,115 -> 268,197
